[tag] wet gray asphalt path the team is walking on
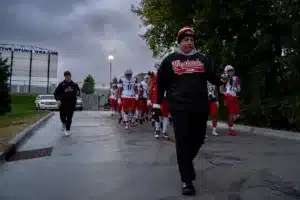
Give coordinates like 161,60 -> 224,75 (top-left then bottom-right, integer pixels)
0,111 -> 300,200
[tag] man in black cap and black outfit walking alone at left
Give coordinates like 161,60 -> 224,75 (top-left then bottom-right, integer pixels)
54,71 -> 80,136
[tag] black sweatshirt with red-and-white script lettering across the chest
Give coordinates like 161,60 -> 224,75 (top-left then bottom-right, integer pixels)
157,52 -> 222,113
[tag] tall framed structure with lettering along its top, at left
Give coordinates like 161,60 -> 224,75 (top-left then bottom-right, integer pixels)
0,44 -> 58,94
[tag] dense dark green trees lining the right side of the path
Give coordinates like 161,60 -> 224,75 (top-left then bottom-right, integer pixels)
131,0 -> 300,131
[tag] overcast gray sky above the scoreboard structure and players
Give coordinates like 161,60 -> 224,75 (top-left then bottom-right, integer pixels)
0,0 -> 154,83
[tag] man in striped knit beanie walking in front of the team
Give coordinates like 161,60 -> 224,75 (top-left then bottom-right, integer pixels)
153,26 -> 222,195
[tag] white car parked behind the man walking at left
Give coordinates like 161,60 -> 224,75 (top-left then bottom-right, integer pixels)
35,94 -> 58,110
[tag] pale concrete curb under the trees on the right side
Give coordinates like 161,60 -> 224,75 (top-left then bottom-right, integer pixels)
207,121 -> 300,141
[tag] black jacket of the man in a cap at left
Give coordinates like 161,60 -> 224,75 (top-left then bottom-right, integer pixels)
54,81 -> 80,105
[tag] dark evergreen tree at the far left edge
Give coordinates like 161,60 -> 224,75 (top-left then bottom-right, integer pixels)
0,54 -> 11,115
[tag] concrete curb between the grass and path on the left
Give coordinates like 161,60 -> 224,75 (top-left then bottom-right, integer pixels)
0,112 -> 54,161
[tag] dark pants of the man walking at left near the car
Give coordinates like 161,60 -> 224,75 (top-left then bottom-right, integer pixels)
59,102 -> 76,131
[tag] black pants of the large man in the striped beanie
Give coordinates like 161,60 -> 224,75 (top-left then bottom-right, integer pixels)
170,110 -> 208,183
